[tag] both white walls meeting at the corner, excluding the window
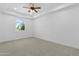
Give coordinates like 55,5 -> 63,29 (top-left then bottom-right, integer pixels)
0,3 -> 79,48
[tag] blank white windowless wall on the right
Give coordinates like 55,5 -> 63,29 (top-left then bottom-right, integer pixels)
34,6 -> 79,48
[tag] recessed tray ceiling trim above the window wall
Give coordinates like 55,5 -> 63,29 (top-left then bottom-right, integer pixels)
0,7 -> 33,19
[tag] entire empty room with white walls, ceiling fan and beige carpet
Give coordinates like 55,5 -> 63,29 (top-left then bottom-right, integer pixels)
0,3 -> 79,56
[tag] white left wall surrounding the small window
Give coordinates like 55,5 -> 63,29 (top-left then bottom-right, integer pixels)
0,13 -> 32,42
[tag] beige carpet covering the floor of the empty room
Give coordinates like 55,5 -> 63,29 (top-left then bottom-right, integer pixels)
0,37 -> 79,56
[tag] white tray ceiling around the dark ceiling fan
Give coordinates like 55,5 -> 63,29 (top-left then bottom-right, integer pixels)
0,3 -> 76,18
